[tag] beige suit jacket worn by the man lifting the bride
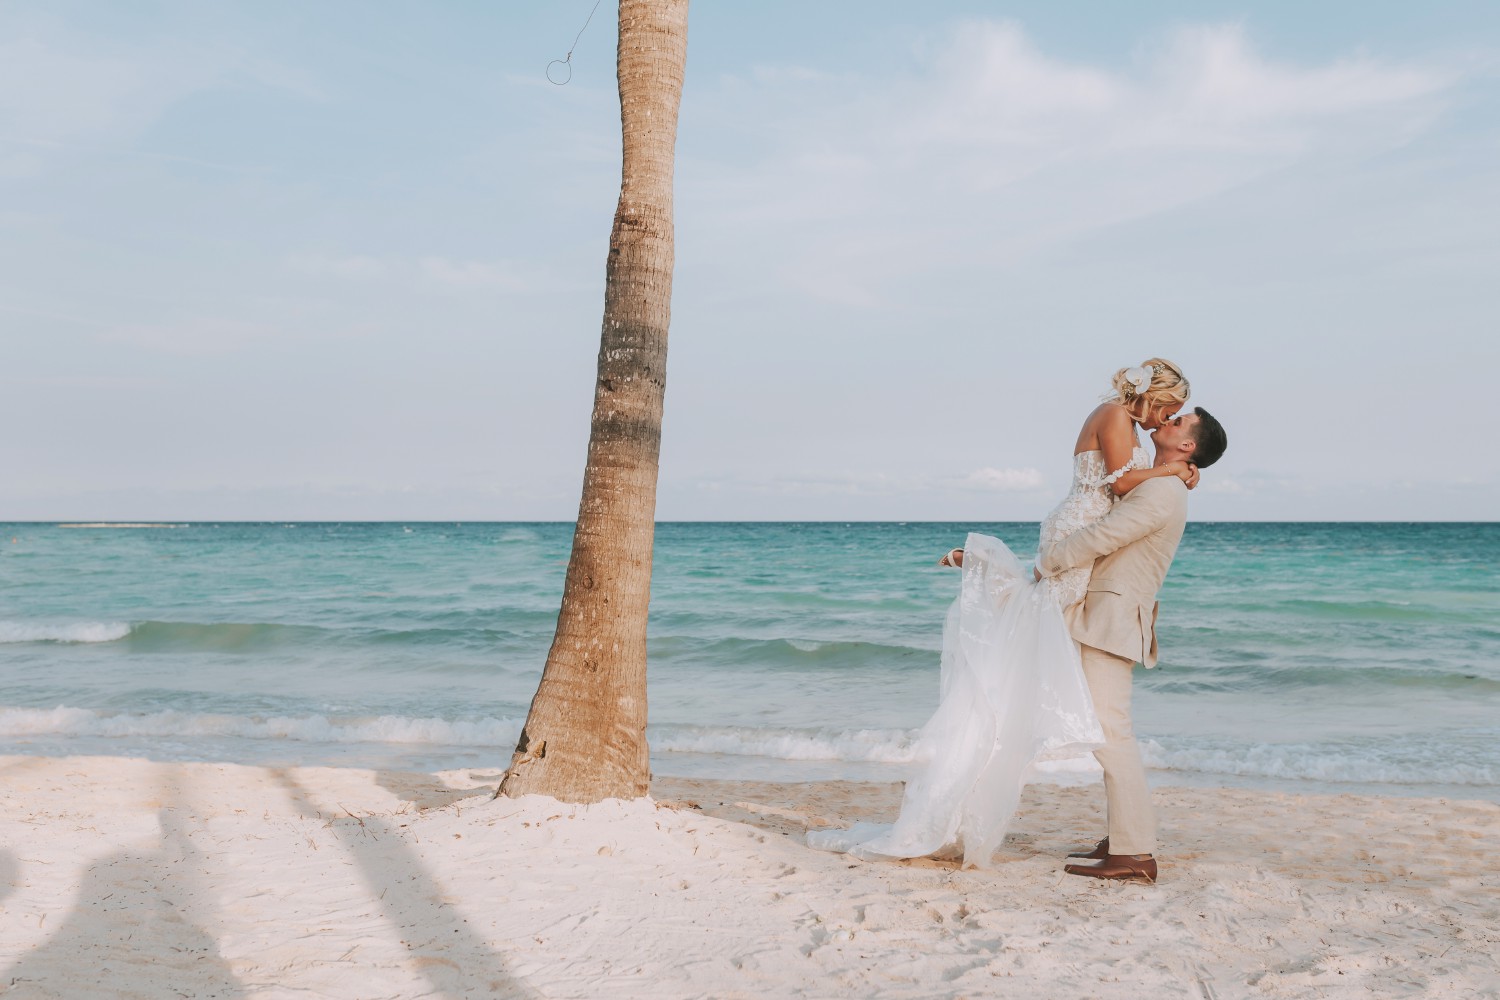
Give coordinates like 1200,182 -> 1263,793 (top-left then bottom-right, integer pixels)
1037,475 -> 1188,667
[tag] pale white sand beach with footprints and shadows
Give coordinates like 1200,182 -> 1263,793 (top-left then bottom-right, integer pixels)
0,757 -> 1500,1000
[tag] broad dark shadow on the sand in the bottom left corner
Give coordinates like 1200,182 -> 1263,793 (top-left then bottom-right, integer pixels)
0,779 -> 249,1000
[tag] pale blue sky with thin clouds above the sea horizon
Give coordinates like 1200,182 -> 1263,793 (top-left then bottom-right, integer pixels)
0,0 -> 1500,520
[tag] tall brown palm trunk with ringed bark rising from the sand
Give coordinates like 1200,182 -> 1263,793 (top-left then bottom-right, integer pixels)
497,0 -> 689,802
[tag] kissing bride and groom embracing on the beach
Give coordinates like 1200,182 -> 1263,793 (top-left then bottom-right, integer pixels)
807,358 -> 1229,882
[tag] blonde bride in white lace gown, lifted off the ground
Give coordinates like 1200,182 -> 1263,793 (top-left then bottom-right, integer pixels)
807,358 -> 1199,867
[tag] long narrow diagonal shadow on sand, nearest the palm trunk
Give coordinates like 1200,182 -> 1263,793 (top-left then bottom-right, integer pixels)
272,768 -> 543,1000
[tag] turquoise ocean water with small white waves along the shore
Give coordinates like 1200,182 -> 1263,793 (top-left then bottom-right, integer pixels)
0,523 -> 1500,799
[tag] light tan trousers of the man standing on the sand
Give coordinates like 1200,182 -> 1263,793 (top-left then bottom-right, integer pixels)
1079,646 -> 1157,855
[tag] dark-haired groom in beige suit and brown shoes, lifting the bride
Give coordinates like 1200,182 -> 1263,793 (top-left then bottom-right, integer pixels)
1037,406 -> 1229,882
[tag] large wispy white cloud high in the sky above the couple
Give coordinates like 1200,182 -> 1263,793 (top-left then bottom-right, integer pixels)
683,22 -> 1458,307
